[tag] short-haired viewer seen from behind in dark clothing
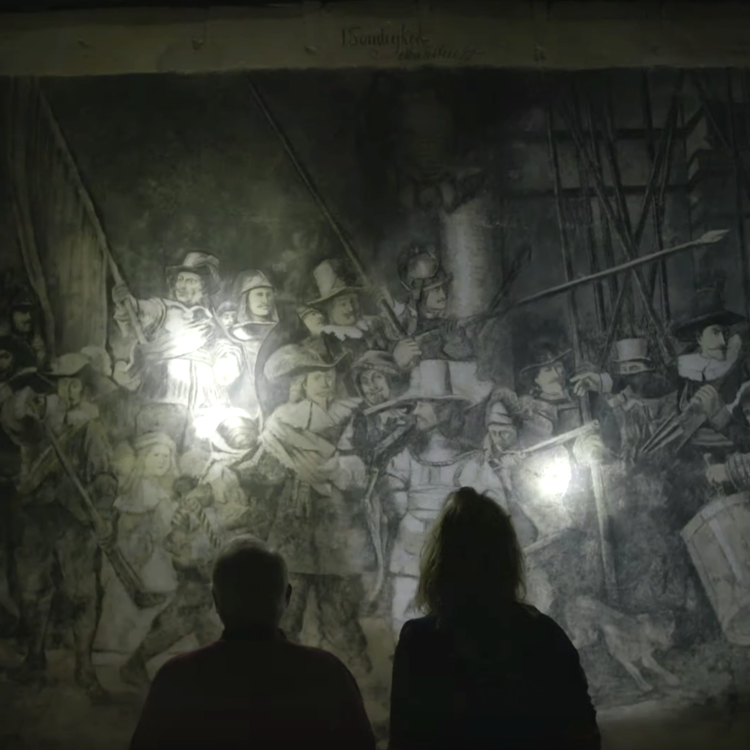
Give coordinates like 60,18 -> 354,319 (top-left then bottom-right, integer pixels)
130,536 -> 375,750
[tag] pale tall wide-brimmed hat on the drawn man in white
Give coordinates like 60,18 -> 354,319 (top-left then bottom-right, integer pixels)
364,359 -> 493,414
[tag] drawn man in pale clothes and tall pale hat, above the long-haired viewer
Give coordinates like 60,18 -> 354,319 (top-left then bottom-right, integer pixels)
373,360 -> 505,633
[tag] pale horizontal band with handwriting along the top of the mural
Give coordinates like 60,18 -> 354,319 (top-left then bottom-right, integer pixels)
0,0 -> 750,76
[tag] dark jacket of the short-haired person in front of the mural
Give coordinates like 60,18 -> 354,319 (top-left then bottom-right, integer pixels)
130,630 -> 375,750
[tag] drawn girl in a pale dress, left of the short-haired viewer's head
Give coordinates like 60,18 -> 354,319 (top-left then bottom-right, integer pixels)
115,432 -> 177,593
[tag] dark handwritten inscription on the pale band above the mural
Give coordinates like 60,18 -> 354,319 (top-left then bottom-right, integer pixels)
341,24 -> 480,63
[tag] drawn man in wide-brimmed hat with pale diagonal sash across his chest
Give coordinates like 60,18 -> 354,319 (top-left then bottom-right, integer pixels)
238,344 -> 375,674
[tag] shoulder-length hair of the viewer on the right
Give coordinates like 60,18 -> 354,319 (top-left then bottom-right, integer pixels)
414,487 -> 525,624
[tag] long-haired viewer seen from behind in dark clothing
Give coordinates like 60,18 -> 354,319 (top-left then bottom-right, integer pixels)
389,487 -> 601,750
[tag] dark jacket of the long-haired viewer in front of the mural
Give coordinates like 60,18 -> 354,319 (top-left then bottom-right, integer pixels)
389,606 -> 600,750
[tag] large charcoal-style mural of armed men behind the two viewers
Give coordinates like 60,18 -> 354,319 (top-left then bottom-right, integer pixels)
0,70 -> 750,748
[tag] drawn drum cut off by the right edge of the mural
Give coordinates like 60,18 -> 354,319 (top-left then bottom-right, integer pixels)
682,492 -> 750,646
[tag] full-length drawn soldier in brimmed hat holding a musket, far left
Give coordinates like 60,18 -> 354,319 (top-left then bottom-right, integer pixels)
2,354 -> 117,700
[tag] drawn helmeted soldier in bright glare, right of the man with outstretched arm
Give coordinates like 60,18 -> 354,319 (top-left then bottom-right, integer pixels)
228,271 -> 279,417
